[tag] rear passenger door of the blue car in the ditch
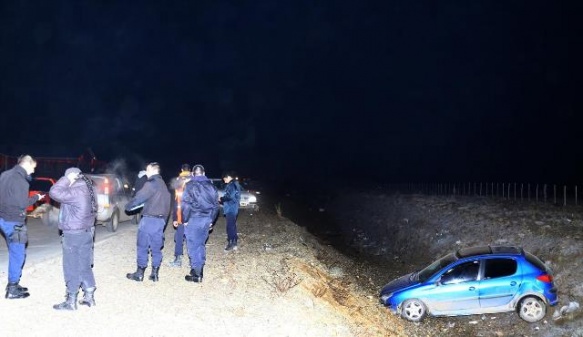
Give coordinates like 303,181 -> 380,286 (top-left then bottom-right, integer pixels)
480,258 -> 522,308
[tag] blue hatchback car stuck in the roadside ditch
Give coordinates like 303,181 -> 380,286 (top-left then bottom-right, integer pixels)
380,246 -> 559,322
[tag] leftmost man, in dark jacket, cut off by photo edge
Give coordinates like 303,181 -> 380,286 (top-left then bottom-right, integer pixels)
0,155 -> 45,299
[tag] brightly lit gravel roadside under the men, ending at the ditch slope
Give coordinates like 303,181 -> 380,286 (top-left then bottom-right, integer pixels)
0,214 -> 405,336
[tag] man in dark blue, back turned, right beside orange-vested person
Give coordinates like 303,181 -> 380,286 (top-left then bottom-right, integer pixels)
182,165 -> 219,282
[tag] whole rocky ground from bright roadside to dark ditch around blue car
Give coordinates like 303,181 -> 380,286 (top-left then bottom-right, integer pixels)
0,192 -> 583,336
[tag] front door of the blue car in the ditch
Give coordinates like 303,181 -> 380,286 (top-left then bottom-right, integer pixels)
425,260 -> 480,314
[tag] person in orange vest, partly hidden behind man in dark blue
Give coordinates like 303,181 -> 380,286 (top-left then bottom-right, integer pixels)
169,164 -> 192,267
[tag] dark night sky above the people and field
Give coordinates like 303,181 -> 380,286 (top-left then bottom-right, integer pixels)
0,0 -> 583,188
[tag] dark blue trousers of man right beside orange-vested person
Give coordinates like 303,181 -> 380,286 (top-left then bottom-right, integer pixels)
184,216 -> 212,271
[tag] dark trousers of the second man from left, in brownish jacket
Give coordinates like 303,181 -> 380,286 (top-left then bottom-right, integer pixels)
62,227 -> 95,294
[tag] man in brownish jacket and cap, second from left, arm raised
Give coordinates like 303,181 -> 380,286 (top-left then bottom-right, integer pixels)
49,167 -> 97,310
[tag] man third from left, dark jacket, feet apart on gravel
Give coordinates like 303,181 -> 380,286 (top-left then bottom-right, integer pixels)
125,162 -> 170,282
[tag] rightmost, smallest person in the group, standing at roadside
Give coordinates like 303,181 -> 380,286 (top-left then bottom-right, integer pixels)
220,171 -> 241,252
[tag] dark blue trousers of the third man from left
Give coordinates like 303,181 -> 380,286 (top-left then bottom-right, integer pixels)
137,216 -> 166,267
